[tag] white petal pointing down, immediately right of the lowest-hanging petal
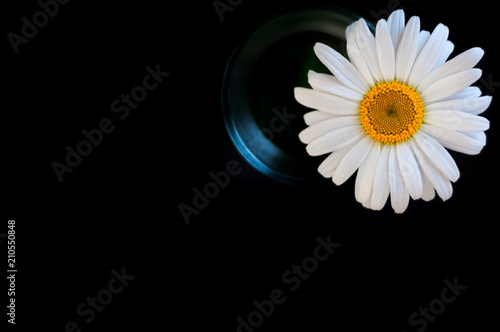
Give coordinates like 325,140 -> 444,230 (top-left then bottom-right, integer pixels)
396,142 -> 423,200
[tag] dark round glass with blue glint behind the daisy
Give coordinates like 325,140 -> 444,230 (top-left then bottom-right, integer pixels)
222,7 -> 364,185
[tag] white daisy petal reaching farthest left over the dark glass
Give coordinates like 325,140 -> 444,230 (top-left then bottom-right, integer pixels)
294,88 -> 359,115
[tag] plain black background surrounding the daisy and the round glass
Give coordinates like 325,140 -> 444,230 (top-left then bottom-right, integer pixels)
0,0 -> 500,332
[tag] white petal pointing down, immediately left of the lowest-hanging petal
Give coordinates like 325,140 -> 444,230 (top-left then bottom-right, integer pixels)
367,145 -> 391,211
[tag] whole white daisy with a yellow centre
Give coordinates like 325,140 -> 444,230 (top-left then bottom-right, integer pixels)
295,10 -> 491,213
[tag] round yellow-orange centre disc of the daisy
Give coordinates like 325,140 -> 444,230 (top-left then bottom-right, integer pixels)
359,80 -> 424,144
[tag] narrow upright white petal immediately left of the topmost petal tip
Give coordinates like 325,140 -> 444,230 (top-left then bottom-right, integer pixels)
375,20 -> 396,82
